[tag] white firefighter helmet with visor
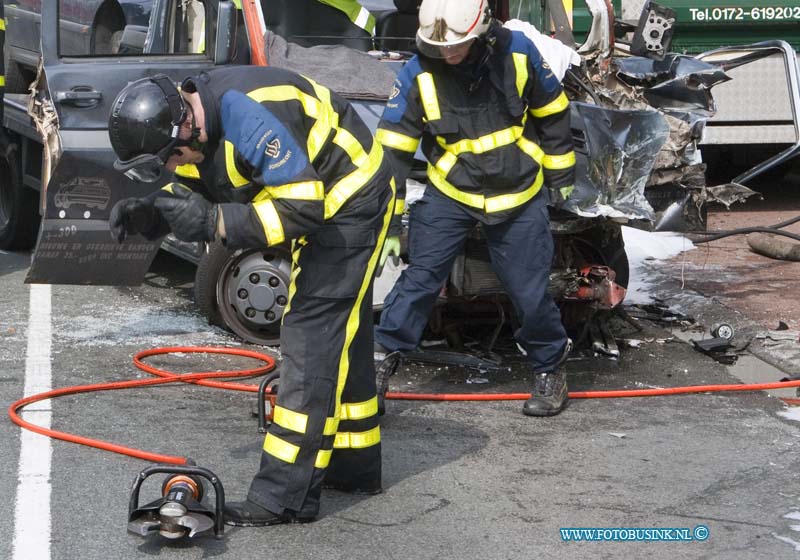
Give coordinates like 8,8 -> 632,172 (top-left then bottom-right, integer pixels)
417,0 -> 492,59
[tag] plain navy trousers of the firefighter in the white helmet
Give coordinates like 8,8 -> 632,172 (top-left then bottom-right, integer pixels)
375,185 -> 567,372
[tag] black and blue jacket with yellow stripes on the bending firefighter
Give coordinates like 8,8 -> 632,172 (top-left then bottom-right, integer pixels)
173,66 -> 391,248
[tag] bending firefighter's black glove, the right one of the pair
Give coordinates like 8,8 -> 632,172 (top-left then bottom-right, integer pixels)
155,185 -> 219,241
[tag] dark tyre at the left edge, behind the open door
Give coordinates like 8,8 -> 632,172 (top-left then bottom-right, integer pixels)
0,140 -> 39,250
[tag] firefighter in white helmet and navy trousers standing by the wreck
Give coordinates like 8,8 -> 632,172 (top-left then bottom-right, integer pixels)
375,0 -> 575,416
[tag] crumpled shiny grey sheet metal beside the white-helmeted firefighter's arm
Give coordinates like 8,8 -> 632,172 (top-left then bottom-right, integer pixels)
565,103 -> 669,221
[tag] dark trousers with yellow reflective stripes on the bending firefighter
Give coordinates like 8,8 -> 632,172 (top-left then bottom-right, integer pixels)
247,183 -> 394,518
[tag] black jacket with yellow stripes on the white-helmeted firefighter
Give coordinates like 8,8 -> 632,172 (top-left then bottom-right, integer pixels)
376,29 -> 575,229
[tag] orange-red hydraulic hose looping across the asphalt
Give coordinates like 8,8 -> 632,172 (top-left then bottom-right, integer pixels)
8,346 -> 800,465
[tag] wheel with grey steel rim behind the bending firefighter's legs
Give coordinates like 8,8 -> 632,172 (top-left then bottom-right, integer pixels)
195,243 -> 291,346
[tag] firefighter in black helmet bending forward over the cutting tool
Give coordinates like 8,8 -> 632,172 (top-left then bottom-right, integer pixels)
109,67 -> 394,526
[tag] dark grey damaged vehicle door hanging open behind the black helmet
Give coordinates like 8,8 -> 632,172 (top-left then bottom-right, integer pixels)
26,0 -> 236,285
